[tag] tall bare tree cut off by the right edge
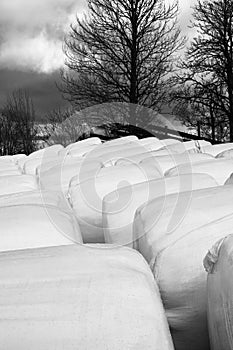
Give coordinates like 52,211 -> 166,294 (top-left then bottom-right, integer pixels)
174,0 -> 233,141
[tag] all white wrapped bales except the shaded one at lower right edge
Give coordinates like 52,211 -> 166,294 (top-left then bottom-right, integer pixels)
0,136 -> 233,350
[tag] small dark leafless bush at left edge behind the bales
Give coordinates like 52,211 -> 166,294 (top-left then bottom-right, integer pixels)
0,90 -> 36,154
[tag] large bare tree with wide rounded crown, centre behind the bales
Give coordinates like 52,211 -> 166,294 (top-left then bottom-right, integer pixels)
61,0 -> 184,124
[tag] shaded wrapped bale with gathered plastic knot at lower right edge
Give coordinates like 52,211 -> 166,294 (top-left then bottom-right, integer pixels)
204,235 -> 233,350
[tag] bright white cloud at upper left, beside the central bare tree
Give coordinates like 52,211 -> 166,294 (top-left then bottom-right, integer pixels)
0,0 -> 85,73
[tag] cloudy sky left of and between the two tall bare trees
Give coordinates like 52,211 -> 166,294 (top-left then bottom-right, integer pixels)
0,0 -> 196,115
